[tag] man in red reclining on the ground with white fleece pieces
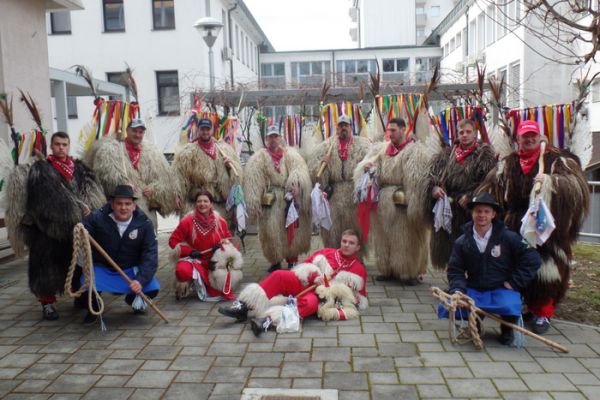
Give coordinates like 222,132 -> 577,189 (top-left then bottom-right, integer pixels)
219,229 -> 369,336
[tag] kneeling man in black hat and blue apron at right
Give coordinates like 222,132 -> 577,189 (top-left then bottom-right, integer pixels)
448,193 -> 541,345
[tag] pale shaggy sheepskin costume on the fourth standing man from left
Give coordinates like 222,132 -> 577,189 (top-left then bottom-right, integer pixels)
243,147 -> 311,264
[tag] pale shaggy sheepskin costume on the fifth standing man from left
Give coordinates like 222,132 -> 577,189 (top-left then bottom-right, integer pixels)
308,136 -> 371,247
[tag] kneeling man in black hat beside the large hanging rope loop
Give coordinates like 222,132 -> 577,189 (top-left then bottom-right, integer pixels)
82,185 -> 160,324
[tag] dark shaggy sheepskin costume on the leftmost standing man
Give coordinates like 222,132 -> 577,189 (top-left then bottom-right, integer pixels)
6,160 -> 106,297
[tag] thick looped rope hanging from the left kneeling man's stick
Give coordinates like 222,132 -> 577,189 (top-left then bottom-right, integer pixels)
65,223 -> 106,330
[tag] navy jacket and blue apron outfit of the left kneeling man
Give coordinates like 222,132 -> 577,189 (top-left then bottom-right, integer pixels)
81,197 -> 160,305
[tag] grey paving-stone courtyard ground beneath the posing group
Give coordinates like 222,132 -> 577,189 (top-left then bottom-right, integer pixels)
0,234 -> 600,400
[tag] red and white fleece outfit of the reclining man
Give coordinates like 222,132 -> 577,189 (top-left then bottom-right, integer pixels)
238,249 -> 369,326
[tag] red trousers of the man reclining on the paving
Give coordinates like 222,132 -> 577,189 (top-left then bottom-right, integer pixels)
259,270 -> 319,318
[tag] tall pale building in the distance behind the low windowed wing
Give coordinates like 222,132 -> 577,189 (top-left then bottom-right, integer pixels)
350,0 -> 456,48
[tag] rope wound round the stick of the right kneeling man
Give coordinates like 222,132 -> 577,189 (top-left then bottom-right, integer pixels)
431,287 -> 483,349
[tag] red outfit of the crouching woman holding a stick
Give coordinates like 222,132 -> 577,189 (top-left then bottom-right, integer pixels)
169,210 -> 242,301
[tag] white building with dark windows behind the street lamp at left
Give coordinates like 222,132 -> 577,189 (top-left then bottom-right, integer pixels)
47,0 -> 272,152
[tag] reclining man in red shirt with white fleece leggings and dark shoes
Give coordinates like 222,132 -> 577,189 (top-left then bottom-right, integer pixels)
219,229 -> 369,336
